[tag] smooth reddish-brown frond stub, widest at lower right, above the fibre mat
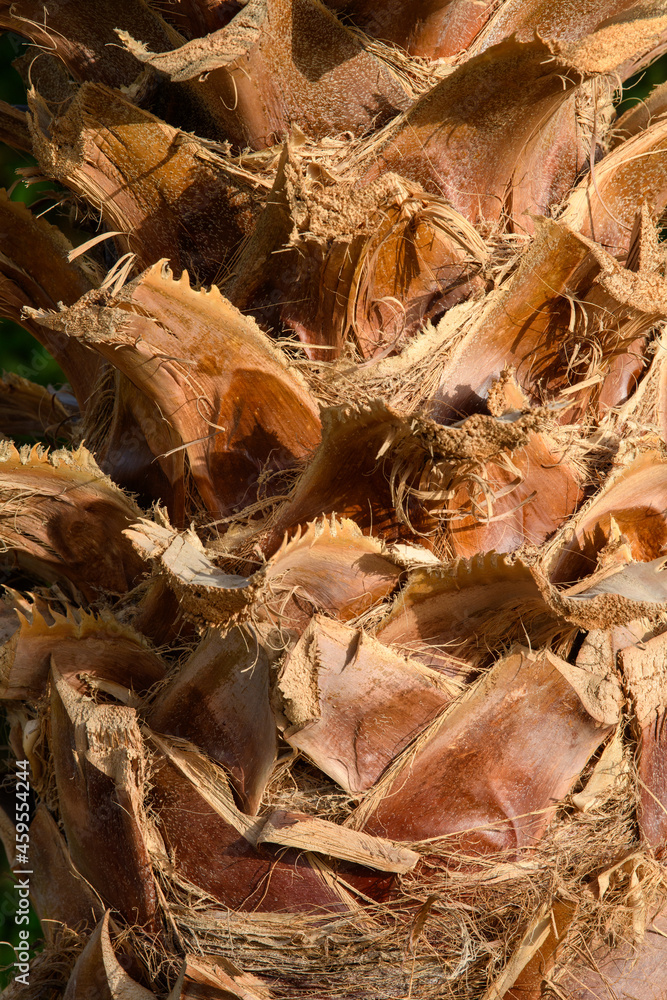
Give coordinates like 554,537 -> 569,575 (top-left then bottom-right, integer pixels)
355,652 -> 618,856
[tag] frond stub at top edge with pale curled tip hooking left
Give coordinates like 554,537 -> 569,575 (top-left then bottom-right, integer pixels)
121,0 -> 409,149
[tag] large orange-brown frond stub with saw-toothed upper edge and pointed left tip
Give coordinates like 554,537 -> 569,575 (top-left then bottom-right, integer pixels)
35,261 -> 320,523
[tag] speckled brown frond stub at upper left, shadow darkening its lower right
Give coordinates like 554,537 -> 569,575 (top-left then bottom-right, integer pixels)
30,84 -> 265,284
